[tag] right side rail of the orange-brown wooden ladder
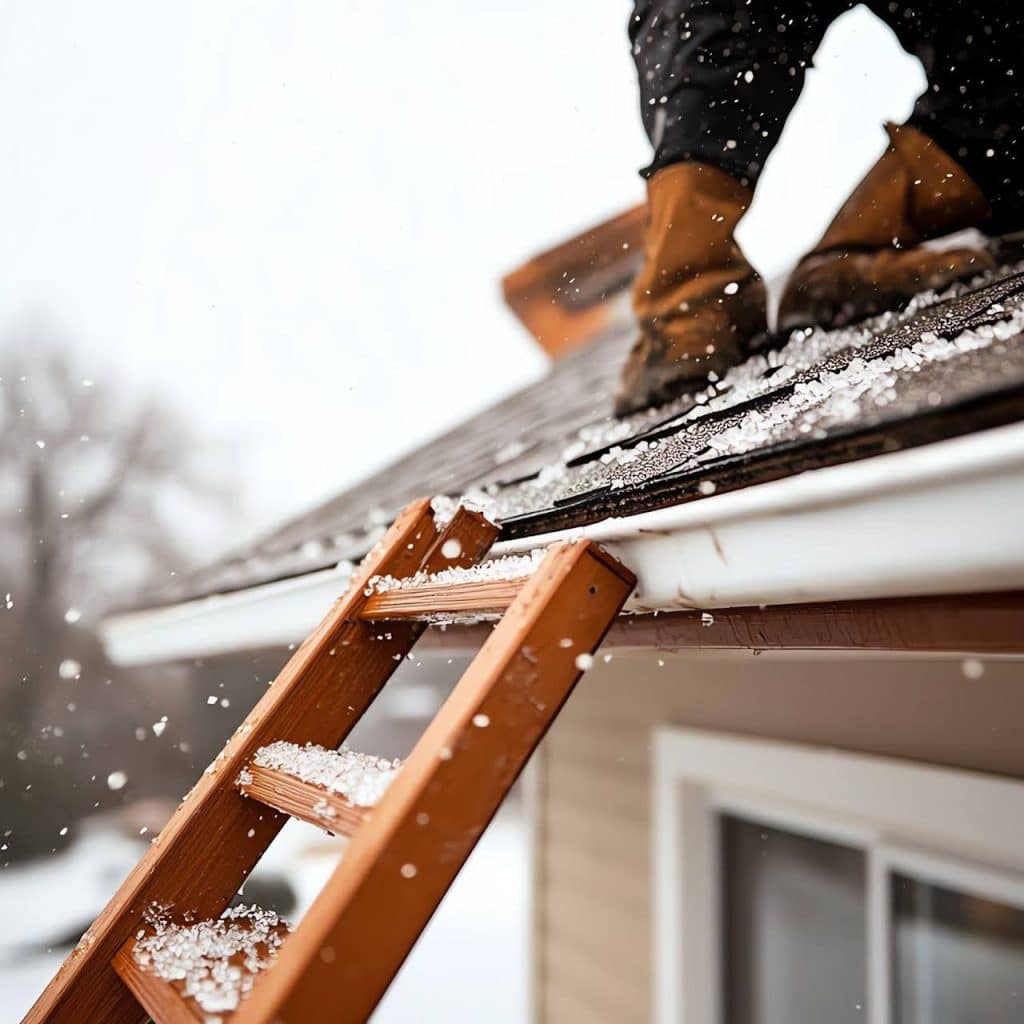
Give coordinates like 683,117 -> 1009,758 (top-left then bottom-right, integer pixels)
236,543 -> 635,1024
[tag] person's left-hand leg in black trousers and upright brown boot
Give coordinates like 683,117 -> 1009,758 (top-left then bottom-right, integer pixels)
616,0 -> 849,413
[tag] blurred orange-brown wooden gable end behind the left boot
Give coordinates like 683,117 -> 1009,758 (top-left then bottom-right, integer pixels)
502,204 -> 647,359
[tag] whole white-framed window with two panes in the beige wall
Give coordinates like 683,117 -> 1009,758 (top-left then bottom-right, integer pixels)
653,729 -> 1024,1024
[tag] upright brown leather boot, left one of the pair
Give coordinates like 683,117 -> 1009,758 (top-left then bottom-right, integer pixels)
615,163 -> 767,416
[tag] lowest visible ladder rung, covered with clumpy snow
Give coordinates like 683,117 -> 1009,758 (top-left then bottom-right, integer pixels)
114,907 -> 290,1024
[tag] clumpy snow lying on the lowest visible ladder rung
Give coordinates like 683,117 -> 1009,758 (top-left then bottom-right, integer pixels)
133,905 -> 290,1022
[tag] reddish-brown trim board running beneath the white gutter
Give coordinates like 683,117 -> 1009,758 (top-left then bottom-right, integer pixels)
420,591 -> 1024,654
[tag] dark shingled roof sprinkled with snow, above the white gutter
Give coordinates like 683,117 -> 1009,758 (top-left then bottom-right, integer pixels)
99,231 -> 1024,663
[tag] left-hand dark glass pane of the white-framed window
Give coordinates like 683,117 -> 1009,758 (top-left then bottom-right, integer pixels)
721,815 -> 866,1024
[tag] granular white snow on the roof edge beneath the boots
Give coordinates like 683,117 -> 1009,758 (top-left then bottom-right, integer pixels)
469,264 -> 1024,521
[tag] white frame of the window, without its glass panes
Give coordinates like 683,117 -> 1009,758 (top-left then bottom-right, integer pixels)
651,727 -> 1024,1024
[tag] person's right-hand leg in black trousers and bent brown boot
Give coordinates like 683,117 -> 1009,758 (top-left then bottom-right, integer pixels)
779,0 -> 1024,330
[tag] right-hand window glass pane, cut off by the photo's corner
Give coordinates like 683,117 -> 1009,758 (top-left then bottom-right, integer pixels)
892,874 -> 1024,1024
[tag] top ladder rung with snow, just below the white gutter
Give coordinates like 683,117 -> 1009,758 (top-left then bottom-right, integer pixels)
359,549 -> 546,623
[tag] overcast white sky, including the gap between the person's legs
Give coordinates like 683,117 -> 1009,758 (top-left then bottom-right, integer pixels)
0,0 -> 923,561
